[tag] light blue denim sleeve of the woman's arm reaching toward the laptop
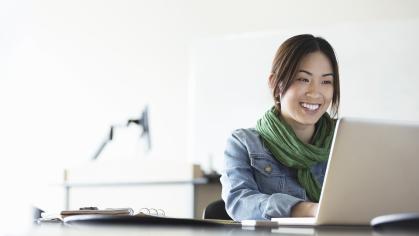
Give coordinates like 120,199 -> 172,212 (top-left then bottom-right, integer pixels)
221,133 -> 304,221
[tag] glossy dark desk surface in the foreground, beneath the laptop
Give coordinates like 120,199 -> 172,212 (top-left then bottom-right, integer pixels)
27,225 -> 419,236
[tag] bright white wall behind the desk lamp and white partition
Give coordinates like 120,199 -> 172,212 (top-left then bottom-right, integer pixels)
0,0 -> 419,229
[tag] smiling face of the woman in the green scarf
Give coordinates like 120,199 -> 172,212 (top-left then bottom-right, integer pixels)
281,51 -> 333,127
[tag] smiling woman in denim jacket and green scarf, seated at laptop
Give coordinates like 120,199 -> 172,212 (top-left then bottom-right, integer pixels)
221,34 -> 340,221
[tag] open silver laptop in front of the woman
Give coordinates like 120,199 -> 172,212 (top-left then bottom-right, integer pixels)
271,118 -> 419,226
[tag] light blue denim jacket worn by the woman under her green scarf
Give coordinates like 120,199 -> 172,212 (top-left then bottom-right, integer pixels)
220,128 -> 327,221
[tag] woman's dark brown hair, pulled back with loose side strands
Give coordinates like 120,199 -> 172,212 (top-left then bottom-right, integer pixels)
269,34 -> 340,117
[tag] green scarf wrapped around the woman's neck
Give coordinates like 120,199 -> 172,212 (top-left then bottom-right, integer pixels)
256,107 -> 336,202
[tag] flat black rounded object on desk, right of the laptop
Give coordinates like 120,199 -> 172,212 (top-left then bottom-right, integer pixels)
371,213 -> 419,231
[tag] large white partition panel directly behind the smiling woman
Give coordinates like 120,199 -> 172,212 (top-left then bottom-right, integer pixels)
188,19 -> 419,170
